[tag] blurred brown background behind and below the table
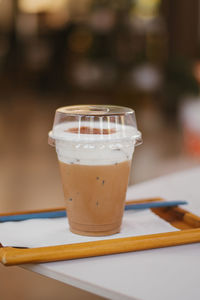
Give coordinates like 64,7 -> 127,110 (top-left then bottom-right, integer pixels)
0,0 -> 200,300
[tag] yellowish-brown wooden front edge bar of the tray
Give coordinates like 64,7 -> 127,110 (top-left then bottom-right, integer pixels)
0,229 -> 200,266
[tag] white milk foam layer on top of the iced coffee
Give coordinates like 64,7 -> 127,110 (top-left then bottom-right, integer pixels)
49,122 -> 140,166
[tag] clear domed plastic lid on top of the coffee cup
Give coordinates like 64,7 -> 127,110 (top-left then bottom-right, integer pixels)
48,105 -> 142,146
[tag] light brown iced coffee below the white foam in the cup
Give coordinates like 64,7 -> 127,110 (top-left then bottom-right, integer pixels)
59,161 -> 131,236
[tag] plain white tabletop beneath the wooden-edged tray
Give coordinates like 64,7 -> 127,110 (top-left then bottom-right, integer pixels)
22,167 -> 200,300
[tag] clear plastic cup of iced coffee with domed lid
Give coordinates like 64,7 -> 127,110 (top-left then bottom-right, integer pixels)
49,105 -> 142,236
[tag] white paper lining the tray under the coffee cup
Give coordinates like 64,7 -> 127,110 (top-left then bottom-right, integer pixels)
0,209 -> 178,248
